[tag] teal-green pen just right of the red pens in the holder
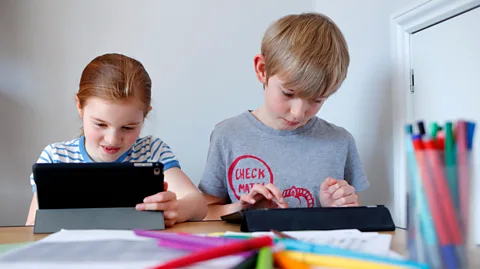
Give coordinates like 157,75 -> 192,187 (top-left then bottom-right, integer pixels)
445,122 -> 459,210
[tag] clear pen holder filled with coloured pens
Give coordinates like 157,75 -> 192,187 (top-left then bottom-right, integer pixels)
407,122 -> 474,269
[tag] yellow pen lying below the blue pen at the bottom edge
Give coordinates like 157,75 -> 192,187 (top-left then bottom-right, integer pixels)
284,251 -> 412,269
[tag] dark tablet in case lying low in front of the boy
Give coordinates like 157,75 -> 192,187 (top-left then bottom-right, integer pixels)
222,205 -> 395,232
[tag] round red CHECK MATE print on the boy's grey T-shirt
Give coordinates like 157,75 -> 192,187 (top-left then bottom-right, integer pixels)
228,155 -> 273,200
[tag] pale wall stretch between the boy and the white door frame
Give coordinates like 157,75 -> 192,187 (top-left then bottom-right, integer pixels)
314,0 -> 415,224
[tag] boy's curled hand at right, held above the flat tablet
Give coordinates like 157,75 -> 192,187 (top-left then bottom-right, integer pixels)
320,177 -> 358,207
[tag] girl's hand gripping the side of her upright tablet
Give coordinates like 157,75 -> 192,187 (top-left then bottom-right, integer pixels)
136,182 -> 178,227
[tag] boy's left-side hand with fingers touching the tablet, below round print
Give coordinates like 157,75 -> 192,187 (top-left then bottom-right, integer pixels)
240,183 -> 288,209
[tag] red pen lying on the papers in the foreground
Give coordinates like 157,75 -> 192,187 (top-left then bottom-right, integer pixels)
152,236 -> 274,269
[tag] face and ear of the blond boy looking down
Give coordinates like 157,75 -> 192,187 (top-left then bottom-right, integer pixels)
254,55 -> 326,130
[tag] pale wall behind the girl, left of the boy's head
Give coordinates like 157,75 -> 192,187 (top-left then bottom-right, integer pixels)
0,0 -> 313,225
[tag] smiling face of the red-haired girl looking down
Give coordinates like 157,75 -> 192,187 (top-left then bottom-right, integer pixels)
77,97 -> 145,162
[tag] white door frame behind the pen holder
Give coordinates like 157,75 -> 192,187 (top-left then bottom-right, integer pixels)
390,0 -> 480,228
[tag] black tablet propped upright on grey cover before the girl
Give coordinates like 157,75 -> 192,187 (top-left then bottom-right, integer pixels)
32,163 -> 165,233
